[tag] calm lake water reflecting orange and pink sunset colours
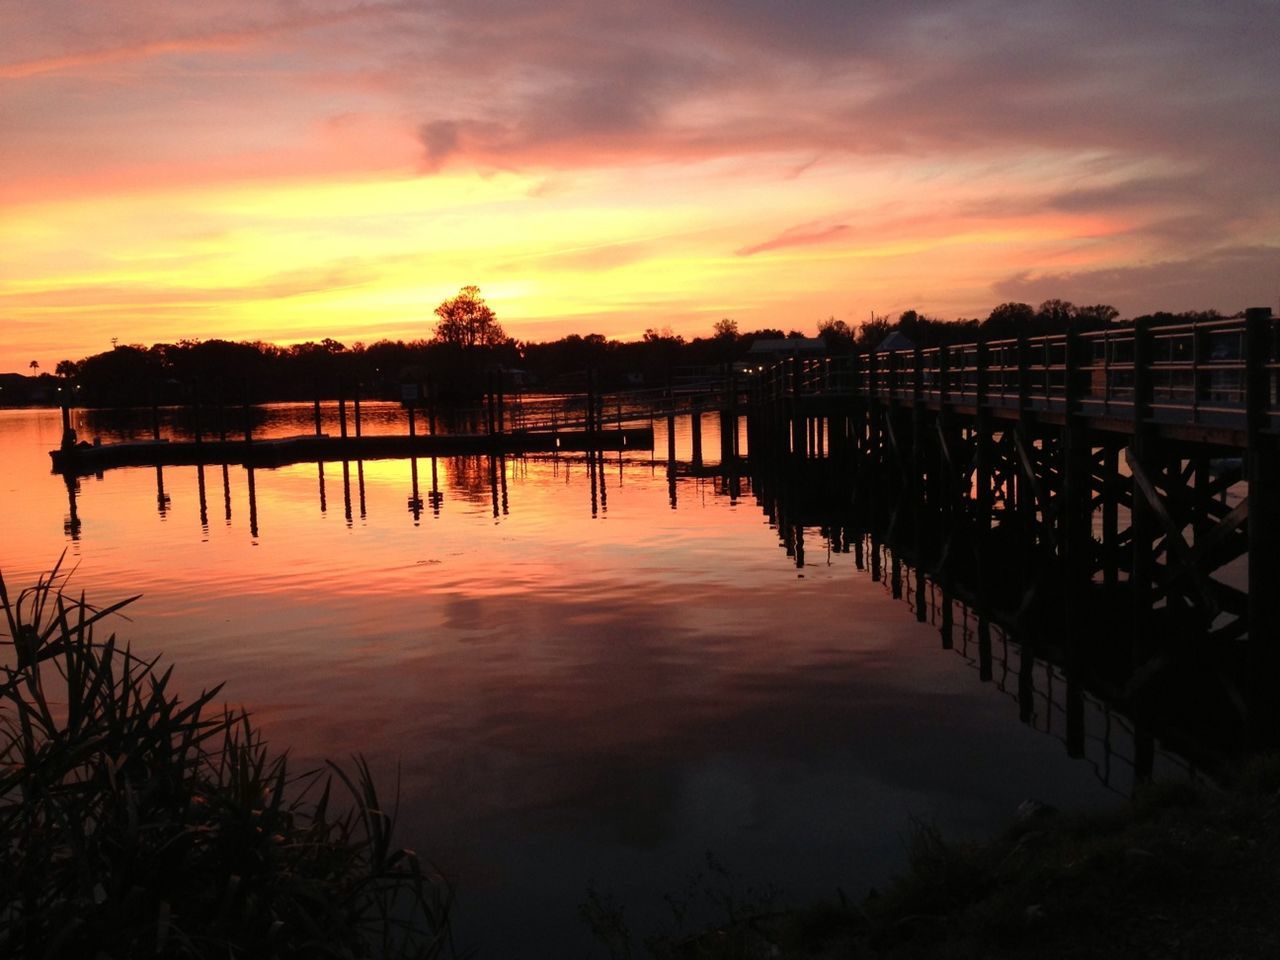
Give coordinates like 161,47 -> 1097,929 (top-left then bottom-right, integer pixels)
0,404 -> 1177,957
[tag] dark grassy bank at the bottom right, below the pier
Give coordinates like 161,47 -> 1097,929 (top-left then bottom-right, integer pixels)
589,773 -> 1280,960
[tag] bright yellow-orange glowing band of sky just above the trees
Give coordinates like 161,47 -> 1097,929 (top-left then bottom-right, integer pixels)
0,150 -> 1146,366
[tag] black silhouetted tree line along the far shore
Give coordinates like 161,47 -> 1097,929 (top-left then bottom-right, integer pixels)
0,287 -> 1239,406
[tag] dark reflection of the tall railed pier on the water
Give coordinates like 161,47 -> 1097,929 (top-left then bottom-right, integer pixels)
753,448 -> 1248,792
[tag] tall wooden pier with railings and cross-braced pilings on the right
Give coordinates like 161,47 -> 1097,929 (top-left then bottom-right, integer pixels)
749,310 -> 1280,740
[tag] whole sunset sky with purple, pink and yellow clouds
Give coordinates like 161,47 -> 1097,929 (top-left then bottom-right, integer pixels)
0,0 -> 1280,372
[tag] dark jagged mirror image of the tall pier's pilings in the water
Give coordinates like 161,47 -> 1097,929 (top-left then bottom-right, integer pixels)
755,450 -> 1251,786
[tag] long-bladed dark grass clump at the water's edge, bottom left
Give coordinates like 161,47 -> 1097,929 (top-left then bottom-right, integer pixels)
0,568 -> 452,960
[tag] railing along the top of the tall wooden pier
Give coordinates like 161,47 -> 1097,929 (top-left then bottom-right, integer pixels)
755,311 -> 1280,430
